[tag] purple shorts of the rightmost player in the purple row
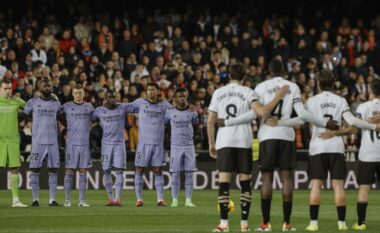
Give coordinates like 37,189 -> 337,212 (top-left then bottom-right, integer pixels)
170,146 -> 198,172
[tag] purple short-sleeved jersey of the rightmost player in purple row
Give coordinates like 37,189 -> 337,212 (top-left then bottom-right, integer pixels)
165,108 -> 199,147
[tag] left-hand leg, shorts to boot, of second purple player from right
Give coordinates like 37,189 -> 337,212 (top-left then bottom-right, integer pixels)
135,143 -> 151,207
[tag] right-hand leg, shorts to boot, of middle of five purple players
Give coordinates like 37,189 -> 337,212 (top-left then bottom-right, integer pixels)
112,143 -> 127,206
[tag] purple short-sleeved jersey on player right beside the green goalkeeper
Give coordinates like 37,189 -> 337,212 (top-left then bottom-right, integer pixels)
24,97 -> 61,144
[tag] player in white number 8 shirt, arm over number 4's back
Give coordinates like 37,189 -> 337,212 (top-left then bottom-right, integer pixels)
207,63 -> 288,232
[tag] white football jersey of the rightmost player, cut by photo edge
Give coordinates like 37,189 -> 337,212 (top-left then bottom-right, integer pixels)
356,99 -> 380,162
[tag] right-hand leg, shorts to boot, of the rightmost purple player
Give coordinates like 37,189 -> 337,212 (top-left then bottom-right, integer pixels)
183,147 -> 197,207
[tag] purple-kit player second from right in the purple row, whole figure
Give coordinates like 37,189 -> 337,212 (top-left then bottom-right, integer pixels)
132,83 -> 171,207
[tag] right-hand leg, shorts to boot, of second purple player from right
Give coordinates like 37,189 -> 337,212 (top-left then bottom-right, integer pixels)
151,144 -> 166,206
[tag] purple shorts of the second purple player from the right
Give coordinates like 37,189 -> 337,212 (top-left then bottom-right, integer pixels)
135,143 -> 165,167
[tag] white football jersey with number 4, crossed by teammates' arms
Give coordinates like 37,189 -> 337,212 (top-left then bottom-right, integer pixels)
255,77 -> 302,142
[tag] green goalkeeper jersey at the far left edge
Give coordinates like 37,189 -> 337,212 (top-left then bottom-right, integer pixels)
0,97 -> 25,143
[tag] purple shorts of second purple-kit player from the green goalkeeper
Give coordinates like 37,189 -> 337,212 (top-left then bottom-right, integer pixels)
65,142 -> 92,169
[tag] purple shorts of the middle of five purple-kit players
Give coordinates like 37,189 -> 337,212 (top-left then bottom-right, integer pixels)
101,142 -> 127,170
